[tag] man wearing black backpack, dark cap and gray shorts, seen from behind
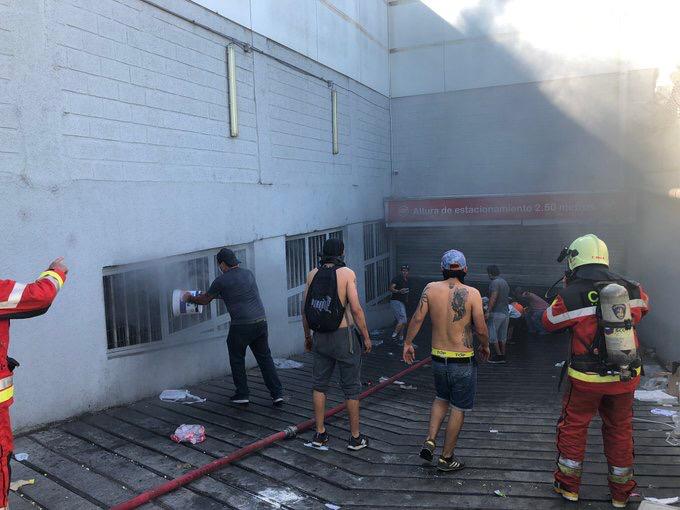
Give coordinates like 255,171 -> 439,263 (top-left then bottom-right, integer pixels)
302,238 -> 371,450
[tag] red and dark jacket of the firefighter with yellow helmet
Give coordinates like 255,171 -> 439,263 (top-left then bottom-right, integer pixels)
543,267 -> 649,394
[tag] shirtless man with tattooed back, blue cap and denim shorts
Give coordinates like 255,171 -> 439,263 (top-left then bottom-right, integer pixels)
404,250 -> 490,471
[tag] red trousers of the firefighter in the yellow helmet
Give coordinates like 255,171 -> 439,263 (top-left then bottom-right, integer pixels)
555,385 -> 636,501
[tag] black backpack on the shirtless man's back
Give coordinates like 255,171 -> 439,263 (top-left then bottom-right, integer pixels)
304,266 -> 345,333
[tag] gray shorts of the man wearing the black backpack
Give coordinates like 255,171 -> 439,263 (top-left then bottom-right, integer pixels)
312,328 -> 362,400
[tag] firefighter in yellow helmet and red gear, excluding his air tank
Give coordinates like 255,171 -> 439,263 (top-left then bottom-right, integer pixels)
543,234 -> 648,508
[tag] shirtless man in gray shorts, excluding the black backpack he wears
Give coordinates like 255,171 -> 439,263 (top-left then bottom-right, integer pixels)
302,239 -> 371,450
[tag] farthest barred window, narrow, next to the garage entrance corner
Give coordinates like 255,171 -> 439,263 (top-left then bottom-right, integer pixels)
364,222 -> 391,305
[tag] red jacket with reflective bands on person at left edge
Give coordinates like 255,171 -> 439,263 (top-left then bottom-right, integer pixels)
0,270 -> 66,408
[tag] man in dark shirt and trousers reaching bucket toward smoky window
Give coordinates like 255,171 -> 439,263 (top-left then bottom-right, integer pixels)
184,248 -> 283,406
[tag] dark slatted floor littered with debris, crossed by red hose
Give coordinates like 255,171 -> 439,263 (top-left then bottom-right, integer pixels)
12,328 -> 680,510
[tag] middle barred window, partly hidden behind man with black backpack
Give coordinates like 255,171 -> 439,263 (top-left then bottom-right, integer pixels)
286,229 -> 343,318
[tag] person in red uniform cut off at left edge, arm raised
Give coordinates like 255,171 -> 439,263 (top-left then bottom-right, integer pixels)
0,258 -> 68,510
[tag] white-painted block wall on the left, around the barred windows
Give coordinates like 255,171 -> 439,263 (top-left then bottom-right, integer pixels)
0,0 -> 390,428
